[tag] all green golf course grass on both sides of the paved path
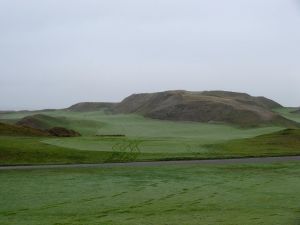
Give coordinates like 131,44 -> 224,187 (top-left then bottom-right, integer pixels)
0,109 -> 300,225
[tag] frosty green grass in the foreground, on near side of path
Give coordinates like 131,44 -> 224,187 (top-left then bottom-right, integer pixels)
0,163 -> 300,225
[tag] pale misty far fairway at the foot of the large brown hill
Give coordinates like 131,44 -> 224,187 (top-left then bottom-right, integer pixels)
0,110 -> 280,137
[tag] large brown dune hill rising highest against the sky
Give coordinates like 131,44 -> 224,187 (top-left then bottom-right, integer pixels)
114,90 -> 298,127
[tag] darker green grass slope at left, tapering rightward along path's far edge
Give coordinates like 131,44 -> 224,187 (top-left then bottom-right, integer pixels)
0,136 -> 176,165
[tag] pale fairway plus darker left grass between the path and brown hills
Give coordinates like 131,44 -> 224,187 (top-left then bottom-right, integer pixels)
0,110 -> 300,164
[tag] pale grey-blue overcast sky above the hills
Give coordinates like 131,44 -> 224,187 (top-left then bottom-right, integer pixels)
0,0 -> 300,110
